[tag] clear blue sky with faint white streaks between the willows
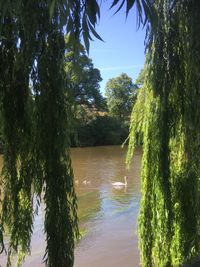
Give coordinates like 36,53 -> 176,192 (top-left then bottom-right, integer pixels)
89,1 -> 145,92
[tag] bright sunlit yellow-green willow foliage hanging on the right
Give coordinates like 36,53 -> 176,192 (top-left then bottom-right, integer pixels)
128,0 -> 200,267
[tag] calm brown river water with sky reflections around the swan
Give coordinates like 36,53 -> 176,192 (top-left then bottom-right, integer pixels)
0,146 -> 142,267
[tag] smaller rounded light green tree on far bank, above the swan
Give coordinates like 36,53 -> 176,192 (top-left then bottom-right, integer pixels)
105,73 -> 138,121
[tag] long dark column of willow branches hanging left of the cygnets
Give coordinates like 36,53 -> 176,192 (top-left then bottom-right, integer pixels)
36,17 -> 78,266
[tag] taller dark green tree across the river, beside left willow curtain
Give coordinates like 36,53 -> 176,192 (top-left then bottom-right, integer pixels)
65,41 -> 104,110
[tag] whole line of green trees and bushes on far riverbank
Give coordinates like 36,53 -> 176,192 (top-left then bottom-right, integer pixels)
66,44 -> 139,146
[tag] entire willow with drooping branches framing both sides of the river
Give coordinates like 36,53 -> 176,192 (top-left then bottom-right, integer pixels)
0,0 -> 200,267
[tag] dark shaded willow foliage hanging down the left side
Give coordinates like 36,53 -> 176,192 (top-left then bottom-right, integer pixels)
0,0 -> 99,267
